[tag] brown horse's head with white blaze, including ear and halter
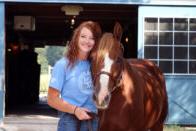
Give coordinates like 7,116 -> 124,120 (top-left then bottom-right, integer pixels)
92,23 -> 123,109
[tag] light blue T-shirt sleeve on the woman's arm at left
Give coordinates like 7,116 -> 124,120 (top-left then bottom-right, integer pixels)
49,59 -> 67,92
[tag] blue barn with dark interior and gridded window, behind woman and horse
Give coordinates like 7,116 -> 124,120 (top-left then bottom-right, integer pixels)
0,0 -> 196,126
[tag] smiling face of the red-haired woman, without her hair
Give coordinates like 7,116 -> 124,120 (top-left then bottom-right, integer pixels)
78,27 -> 95,56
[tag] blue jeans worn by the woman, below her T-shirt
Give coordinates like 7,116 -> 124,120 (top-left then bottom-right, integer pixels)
57,112 -> 98,131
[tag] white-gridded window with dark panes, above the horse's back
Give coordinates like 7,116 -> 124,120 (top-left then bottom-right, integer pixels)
143,17 -> 196,75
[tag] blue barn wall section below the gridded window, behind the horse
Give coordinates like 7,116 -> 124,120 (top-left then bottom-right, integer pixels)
166,76 -> 196,125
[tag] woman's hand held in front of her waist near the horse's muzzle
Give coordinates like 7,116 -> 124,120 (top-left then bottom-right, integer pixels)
74,107 -> 91,120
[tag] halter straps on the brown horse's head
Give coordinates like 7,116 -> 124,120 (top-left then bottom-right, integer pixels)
94,57 -> 124,93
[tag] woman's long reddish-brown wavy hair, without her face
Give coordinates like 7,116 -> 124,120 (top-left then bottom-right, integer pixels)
66,21 -> 102,67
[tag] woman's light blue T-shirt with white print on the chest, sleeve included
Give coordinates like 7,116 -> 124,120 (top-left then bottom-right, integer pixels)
49,57 -> 97,113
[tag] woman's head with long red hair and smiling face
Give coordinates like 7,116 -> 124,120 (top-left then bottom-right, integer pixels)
66,21 -> 102,67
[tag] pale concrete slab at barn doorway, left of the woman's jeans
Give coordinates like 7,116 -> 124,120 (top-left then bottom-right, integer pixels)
0,115 -> 58,131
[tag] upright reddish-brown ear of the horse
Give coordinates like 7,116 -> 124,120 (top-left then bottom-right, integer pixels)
113,22 -> 123,41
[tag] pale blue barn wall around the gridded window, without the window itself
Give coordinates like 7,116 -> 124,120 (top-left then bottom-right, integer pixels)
138,6 -> 196,125
